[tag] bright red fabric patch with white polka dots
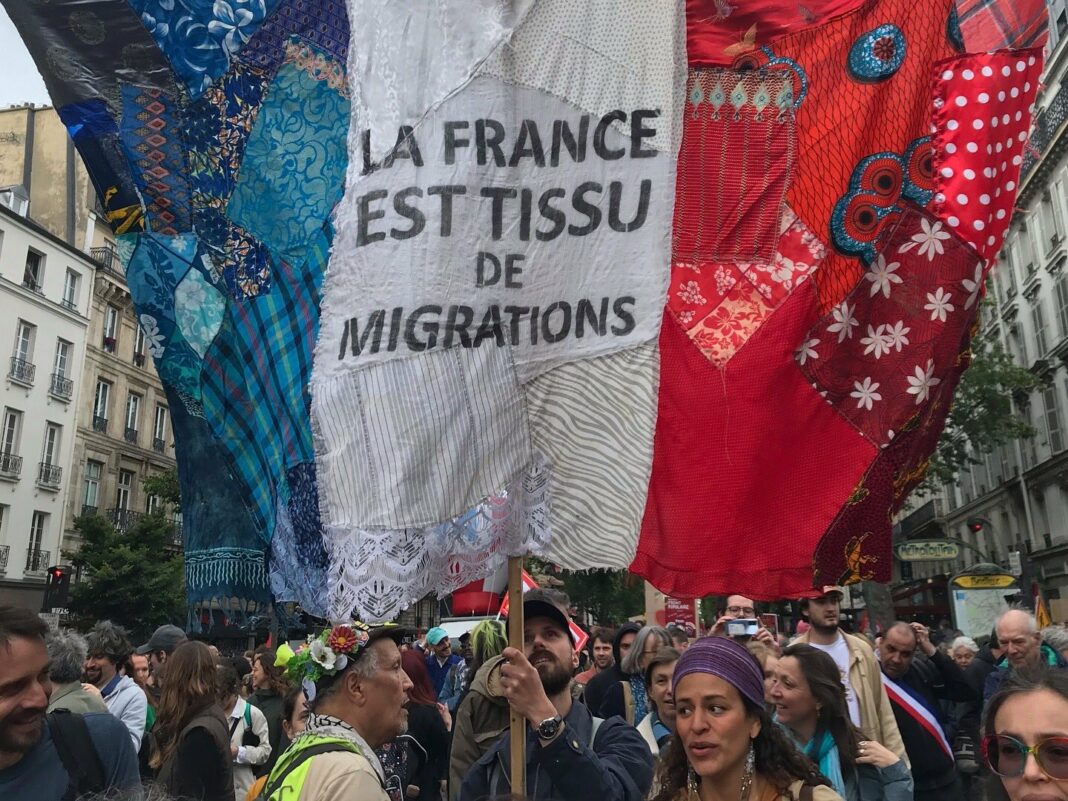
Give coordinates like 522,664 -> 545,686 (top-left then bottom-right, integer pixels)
933,49 -> 1042,261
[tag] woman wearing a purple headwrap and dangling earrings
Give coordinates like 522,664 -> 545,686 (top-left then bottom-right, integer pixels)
653,637 -> 841,801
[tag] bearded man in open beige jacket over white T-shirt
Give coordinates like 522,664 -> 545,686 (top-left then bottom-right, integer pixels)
794,586 -> 909,765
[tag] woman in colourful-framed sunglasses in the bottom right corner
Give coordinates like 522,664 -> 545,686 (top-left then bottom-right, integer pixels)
983,670 -> 1068,801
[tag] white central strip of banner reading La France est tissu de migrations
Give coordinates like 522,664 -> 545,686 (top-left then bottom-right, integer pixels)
312,0 -> 685,621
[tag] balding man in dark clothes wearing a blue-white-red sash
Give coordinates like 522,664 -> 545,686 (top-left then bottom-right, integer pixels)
879,623 -> 976,801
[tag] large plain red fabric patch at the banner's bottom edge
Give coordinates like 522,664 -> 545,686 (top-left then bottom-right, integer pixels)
631,282 -> 876,599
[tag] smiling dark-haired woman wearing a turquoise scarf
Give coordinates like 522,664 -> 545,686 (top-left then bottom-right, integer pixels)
768,643 -> 912,801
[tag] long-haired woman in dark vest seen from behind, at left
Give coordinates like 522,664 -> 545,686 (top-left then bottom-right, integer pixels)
152,641 -> 234,801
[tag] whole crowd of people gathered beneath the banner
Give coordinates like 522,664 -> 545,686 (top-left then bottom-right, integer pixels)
0,587 -> 1068,801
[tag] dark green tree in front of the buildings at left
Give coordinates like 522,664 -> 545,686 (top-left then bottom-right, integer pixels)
69,514 -> 186,640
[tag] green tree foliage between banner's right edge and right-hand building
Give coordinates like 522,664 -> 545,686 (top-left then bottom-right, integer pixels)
917,336 -> 1041,494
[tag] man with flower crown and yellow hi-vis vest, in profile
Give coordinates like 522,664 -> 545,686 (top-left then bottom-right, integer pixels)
260,623 -> 411,801
